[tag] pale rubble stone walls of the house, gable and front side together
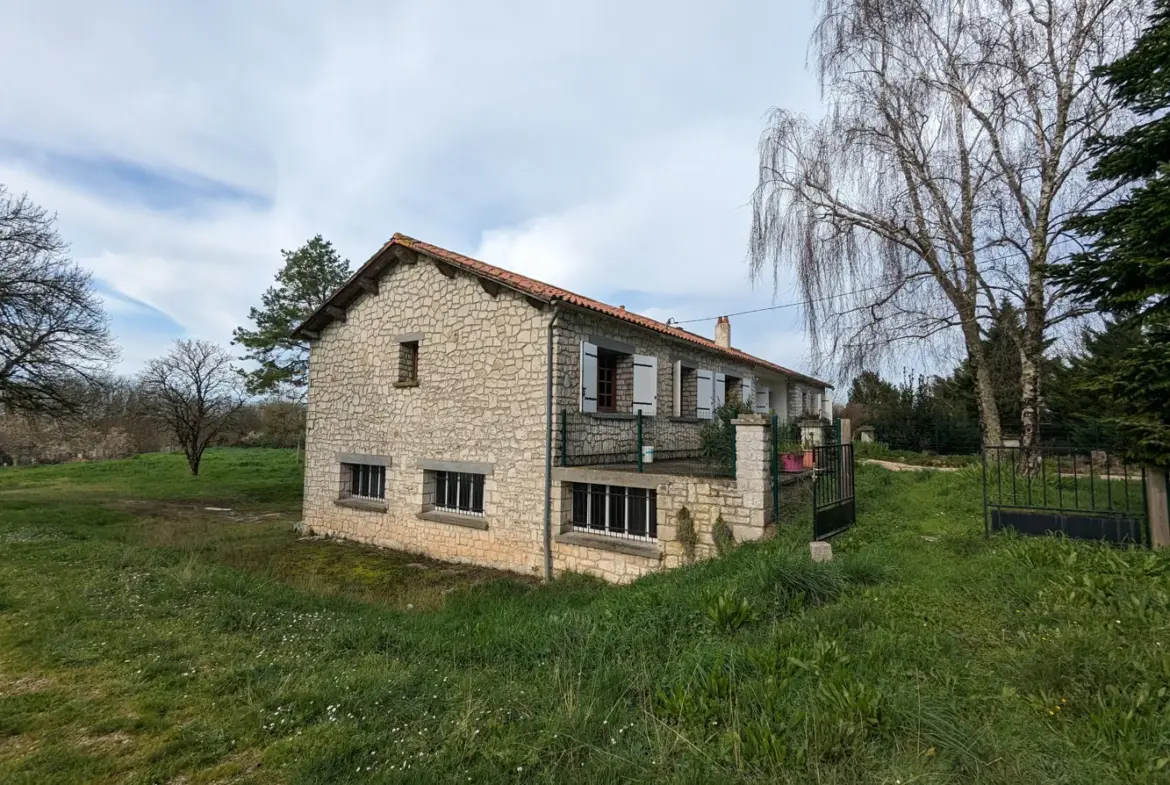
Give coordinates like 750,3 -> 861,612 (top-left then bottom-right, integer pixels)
304,251 -> 804,581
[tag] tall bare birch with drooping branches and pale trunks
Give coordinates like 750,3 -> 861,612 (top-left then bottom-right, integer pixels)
749,0 -> 1143,448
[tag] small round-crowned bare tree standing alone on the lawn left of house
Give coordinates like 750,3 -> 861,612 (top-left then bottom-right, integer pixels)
139,340 -> 245,476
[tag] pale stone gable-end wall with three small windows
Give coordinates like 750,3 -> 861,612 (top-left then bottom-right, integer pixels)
304,260 -> 551,574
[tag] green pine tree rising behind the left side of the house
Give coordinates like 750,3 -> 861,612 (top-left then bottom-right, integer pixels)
232,234 -> 350,399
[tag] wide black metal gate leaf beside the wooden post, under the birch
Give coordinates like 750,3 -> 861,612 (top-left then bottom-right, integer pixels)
983,447 -> 1149,545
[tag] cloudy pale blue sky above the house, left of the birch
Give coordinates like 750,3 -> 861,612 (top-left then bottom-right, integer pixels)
0,0 -> 818,371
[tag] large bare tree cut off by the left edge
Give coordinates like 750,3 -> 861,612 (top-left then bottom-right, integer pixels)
0,185 -> 117,414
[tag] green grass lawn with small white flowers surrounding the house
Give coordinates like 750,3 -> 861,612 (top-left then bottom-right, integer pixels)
0,450 -> 1170,785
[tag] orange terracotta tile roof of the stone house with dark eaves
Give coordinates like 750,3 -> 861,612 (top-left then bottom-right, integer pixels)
297,234 -> 832,387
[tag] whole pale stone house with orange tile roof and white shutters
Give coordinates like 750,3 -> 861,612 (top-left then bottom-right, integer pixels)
297,234 -> 832,581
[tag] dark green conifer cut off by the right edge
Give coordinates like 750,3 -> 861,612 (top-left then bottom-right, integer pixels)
1058,0 -> 1170,464
